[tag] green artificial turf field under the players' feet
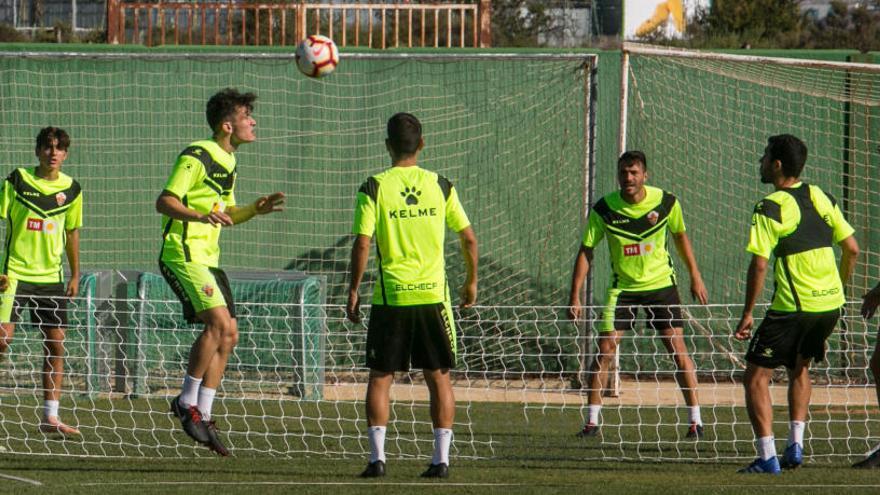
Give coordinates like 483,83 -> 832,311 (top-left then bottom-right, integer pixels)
0,399 -> 880,495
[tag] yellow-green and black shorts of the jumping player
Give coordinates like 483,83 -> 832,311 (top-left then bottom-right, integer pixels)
159,260 -> 235,323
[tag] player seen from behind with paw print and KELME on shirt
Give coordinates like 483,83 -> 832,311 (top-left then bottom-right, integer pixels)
345,113 -> 477,478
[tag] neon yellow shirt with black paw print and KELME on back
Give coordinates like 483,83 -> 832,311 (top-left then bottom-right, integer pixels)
352,166 -> 470,306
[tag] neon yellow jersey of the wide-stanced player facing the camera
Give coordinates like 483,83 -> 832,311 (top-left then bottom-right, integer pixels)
583,186 -> 685,291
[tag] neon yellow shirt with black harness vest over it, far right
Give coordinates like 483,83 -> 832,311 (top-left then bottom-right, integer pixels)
746,182 -> 854,313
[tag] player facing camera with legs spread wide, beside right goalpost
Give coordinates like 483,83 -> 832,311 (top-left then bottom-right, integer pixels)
569,151 -> 708,439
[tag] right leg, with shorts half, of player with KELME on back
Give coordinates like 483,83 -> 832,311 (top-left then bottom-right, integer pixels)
411,302 -> 458,478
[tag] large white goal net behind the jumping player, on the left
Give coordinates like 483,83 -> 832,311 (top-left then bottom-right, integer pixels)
0,48 -> 596,457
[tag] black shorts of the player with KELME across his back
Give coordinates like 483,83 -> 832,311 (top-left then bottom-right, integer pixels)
366,303 -> 457,372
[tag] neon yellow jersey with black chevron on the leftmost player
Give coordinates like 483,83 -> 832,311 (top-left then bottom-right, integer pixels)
0,167 -> 83,284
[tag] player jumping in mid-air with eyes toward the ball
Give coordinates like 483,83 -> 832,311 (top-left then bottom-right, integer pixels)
156,88 -> 284,456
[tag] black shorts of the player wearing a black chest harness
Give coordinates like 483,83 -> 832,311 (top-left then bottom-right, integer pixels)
746,309 -> 840,369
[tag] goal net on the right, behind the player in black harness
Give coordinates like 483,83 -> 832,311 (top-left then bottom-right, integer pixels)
597,45 -> 880,464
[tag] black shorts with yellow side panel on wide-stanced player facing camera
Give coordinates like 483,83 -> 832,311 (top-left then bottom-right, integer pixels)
601,285 -> 684,332
